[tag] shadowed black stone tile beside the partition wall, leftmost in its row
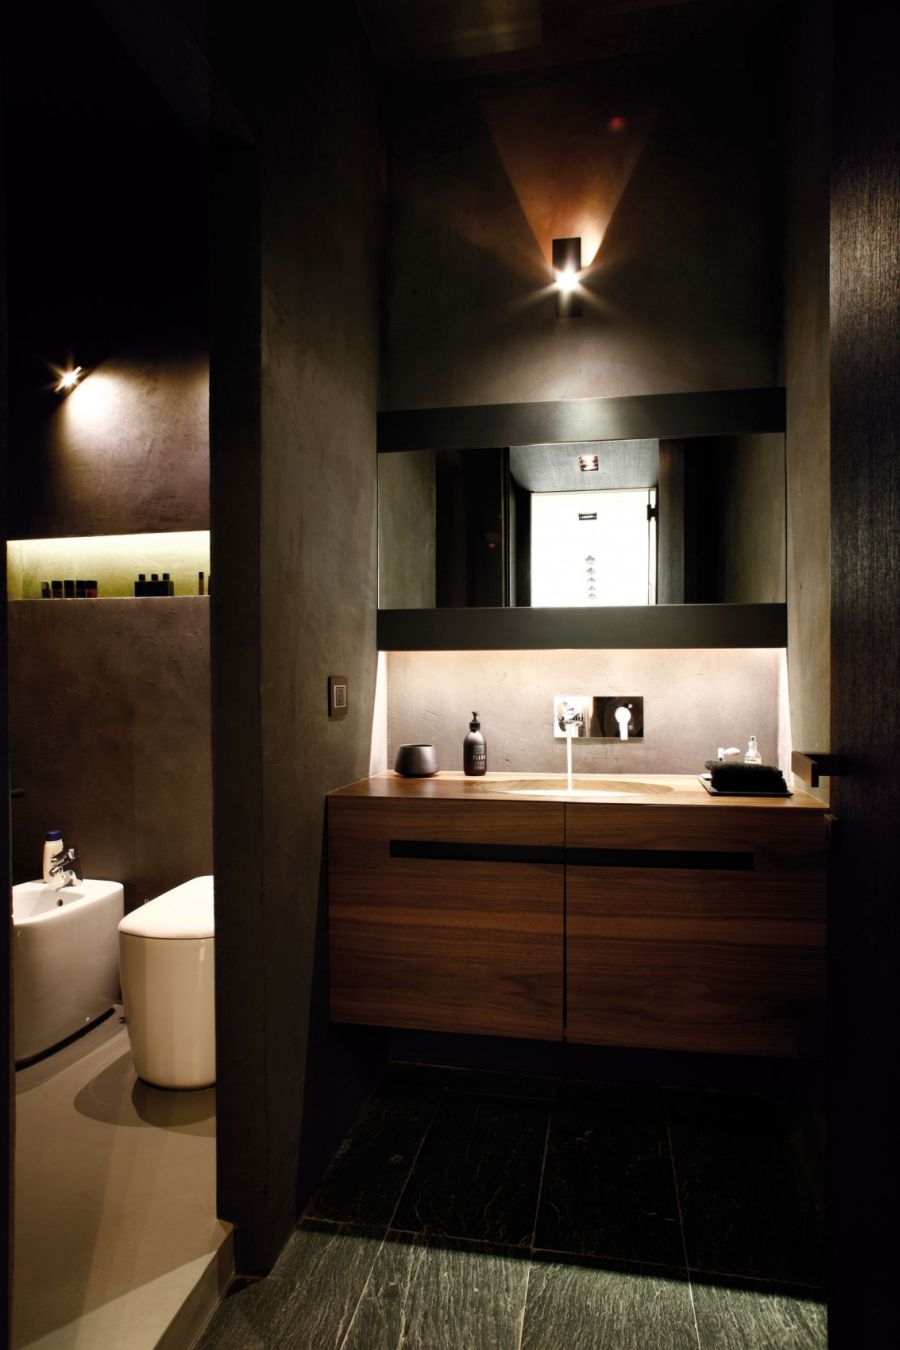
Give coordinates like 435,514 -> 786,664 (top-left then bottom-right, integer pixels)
306,1065 -> 444,1227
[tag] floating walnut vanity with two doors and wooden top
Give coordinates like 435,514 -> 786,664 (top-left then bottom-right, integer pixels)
328,772 -> 826,1057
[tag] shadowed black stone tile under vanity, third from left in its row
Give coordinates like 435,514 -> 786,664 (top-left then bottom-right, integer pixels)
534,1088 -> 684,1268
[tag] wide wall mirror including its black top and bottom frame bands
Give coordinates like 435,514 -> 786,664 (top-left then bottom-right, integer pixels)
378,389 -> 787,649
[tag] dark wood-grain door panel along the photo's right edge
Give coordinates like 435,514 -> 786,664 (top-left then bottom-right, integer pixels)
828,0 -> 900,1350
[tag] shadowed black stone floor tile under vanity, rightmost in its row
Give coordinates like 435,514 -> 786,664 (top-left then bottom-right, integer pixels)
667,1092 -> 824,1287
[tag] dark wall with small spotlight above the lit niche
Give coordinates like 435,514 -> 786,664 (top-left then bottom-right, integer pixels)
3,0 -> 208,539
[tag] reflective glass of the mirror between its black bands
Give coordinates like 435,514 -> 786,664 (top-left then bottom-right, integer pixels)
378,432 -> 785,609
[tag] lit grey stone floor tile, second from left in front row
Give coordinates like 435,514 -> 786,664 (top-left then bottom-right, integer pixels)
344,1235 -> 529,1350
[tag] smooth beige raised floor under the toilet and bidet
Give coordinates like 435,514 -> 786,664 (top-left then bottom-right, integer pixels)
12,1010 -> 232,1350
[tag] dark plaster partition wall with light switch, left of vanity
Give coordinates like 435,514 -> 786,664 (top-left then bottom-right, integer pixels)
210,3 -> 382,1272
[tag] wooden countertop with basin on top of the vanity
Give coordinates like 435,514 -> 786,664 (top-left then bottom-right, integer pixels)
328,770 -> 828,811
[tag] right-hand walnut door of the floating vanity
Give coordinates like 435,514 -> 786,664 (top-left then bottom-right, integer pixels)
567,805 -> 826,1057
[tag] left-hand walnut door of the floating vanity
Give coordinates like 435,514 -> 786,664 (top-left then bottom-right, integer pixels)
328,797 -> 564,1041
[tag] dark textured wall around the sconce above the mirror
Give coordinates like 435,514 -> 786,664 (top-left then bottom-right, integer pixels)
386,38 -> 780,408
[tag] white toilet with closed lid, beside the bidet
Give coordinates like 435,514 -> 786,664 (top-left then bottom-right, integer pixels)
119,876 -> 216,1088
